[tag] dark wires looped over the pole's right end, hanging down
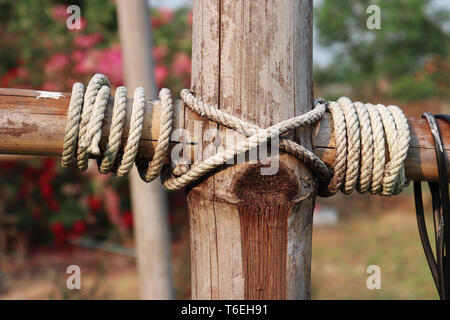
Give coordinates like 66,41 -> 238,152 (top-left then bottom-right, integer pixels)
414,112 -> 450,300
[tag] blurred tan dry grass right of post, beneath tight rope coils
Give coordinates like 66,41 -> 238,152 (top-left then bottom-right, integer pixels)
312,188 -> 438,299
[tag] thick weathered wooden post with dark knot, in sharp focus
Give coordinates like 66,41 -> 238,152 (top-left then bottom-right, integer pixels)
185,0 -> 316,299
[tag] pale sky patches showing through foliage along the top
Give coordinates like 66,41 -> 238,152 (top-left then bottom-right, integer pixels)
148,0 -> 450,66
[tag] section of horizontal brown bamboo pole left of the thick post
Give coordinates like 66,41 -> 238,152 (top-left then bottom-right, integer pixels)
0,88 -> 183,158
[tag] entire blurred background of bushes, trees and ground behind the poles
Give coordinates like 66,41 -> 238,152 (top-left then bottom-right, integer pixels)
0,0 -> 450,299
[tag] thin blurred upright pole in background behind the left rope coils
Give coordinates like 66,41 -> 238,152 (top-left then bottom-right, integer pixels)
117,0 -> 173,299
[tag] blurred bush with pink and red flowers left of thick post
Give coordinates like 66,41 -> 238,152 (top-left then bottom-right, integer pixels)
0,0 -> 192,246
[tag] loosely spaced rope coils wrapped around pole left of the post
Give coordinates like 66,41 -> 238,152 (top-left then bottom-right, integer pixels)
61,74 -> 173,182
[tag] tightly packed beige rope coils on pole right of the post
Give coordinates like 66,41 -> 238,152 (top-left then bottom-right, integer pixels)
322,97 -> 410,196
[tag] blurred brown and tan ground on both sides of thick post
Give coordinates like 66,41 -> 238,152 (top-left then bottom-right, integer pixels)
0,184 -> 437,299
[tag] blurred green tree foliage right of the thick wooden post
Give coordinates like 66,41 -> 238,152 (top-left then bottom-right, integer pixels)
315,0 -> 450,99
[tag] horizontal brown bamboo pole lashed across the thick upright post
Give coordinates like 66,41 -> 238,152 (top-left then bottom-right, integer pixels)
0,88 -> 450,181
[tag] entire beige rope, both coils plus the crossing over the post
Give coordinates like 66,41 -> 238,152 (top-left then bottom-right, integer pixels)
61,74 -> 409,196
